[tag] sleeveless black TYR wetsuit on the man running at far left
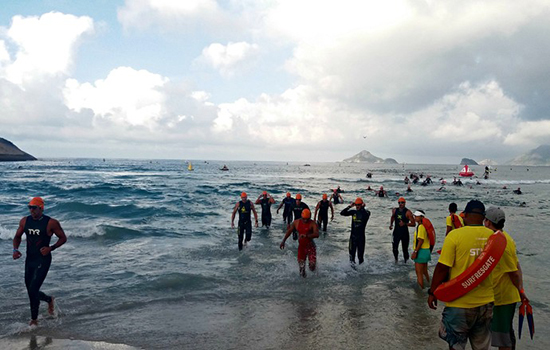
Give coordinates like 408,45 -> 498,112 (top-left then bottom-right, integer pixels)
23,215 -> 52,320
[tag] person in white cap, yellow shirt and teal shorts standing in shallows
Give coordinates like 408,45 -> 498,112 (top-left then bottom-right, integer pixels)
411,210 -> 431,289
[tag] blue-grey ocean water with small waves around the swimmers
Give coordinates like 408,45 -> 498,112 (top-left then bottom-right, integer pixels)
0,159 -> 550,350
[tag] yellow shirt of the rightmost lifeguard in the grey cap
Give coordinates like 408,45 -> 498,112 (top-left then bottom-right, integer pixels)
492,231 -> 521,305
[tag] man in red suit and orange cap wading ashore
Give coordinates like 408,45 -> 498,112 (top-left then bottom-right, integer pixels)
279,208 -> 319,277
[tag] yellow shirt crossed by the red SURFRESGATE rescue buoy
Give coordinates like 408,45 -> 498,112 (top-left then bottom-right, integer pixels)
439,226 -> 495,309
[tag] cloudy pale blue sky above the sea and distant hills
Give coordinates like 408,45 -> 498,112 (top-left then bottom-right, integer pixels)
0,0 -> 550,164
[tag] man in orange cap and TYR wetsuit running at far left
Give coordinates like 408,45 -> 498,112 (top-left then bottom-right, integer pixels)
13,197 -> 67,326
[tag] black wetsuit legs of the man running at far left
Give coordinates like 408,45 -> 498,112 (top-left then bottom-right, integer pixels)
25,255 -> 52,320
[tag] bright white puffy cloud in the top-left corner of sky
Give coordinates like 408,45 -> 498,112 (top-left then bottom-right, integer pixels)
0,12 -> 94,86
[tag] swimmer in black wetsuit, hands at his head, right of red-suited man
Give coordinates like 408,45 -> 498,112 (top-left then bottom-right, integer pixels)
340,197 -> 370,267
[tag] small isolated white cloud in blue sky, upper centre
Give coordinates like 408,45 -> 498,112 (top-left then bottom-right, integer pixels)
198,41 -> 259,77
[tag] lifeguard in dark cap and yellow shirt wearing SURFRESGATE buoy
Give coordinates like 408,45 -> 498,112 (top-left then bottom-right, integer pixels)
428,200 -> 495,350
